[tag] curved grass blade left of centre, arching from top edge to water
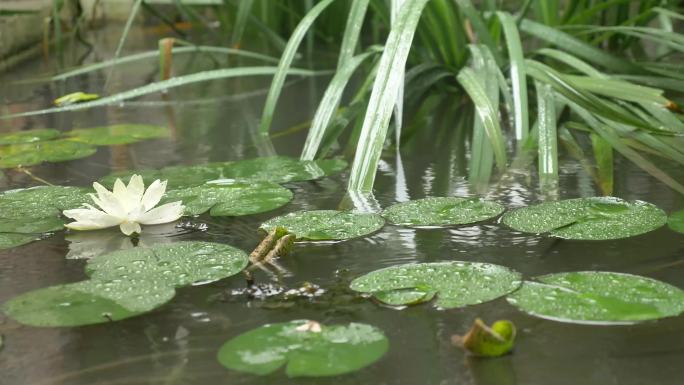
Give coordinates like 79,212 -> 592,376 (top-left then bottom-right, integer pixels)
259,0 -> 333,135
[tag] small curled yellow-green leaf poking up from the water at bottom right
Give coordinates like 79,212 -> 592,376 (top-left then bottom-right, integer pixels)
451,318 -> 516,357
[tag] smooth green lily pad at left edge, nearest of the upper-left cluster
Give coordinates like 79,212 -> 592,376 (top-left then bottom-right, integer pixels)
0,140 -> 97,168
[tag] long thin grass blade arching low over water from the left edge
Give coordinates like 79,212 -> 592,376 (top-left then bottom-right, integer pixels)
0,67 -> 329,119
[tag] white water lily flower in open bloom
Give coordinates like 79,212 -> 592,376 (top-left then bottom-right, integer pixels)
64,175 -> 185,235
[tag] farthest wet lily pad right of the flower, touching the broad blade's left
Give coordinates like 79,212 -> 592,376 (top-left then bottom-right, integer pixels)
223,156 -> 347,183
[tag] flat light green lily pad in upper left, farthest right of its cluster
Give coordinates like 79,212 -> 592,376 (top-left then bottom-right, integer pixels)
64,124 -> 171,146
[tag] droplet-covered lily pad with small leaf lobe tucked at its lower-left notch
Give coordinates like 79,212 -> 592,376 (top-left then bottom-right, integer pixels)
349,261 -> 521,309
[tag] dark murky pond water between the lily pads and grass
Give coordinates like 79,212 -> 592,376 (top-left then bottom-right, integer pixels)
0,25 -> 684,385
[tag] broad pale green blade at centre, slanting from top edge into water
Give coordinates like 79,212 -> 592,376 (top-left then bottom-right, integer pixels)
348,0 -> 428,193
